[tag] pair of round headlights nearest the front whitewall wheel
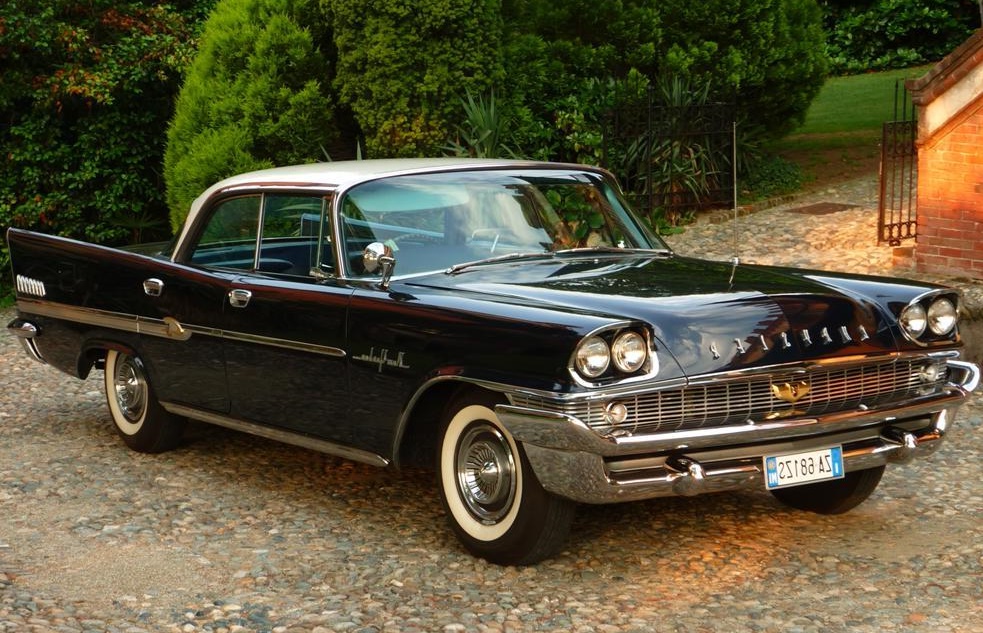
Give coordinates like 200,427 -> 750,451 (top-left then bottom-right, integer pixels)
572,328 -> 657,383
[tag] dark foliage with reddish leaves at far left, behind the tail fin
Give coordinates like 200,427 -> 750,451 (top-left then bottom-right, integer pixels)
0,0 -> 210,246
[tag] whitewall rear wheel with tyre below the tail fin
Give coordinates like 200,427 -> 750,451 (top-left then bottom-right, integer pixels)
104,350 -> 186,453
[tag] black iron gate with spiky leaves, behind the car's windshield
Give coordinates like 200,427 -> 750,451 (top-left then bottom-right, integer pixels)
602,88 -> 735,224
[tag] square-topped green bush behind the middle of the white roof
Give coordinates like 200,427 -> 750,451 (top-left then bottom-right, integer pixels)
322,0 -> 502,158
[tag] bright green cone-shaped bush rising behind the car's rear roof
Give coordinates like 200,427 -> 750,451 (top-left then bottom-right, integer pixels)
164,0 -> 340,230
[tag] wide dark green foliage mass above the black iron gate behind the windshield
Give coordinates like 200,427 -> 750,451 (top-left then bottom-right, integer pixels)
498,0 -> 826,160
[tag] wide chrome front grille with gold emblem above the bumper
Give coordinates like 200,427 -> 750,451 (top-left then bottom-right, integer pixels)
512,359 -> 945,434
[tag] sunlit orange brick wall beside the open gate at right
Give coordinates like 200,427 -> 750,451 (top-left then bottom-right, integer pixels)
915,98 -> 983,278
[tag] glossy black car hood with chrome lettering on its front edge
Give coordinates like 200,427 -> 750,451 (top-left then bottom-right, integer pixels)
404,254 -> 897,376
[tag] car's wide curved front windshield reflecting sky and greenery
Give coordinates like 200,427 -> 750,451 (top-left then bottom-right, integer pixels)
340,170 -> 666,276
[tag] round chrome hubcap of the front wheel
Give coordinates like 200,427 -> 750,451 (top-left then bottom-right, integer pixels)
457,423 -> 516,524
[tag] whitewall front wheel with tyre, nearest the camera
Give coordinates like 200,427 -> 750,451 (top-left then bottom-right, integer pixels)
437,393 -> 576,565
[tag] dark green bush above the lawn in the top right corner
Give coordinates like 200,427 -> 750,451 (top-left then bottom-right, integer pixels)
823,0 -> 980,73
